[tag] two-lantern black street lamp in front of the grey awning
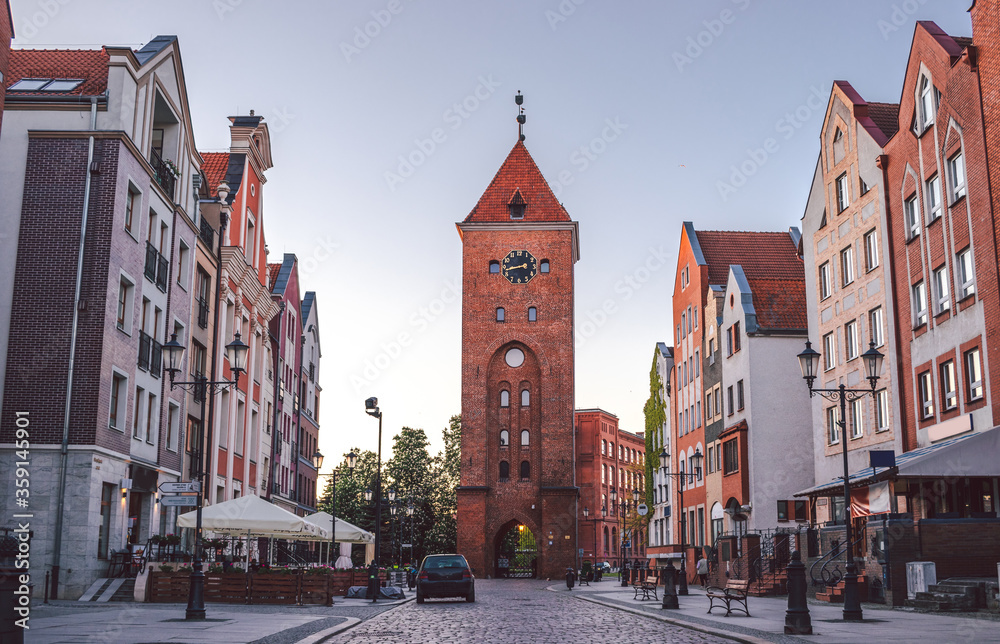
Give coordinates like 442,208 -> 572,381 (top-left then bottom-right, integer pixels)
798,340 -> 885,622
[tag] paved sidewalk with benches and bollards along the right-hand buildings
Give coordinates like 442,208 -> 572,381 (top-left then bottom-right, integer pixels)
564,580 -> 1000,644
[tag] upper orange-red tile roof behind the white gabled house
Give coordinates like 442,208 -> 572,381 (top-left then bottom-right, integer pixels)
696,230 -> 803,286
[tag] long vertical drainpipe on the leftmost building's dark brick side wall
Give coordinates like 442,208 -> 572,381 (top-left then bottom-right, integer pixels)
50,96 -> 97,599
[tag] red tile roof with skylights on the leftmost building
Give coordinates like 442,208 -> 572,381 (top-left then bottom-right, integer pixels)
4,49 -> 111,96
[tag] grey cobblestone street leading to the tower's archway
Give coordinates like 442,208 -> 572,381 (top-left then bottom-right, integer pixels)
329,579 -> 729,644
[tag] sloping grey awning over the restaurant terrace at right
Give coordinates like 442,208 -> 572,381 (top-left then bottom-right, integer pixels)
794,427 -> 1000,496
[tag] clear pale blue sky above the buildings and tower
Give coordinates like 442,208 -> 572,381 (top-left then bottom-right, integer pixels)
11,0 -> 971,462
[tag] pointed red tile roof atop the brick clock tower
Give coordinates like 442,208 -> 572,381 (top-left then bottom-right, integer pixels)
464,141 -> 571,223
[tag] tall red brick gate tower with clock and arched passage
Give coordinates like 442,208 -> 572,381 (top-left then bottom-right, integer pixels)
456,130 -> 580,578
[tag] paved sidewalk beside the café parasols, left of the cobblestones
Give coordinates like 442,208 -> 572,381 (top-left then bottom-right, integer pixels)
18,593 -> 413,644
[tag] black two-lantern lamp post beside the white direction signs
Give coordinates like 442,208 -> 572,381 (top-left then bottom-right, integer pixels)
163,333 -> 250,620
